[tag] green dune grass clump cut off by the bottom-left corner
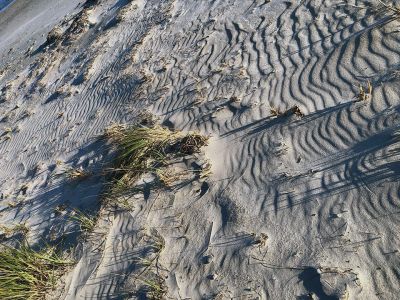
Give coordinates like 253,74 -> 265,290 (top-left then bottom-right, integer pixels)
0,243 -> 72,300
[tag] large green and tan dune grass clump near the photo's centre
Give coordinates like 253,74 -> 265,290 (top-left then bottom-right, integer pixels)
105,124 -> 207,203
